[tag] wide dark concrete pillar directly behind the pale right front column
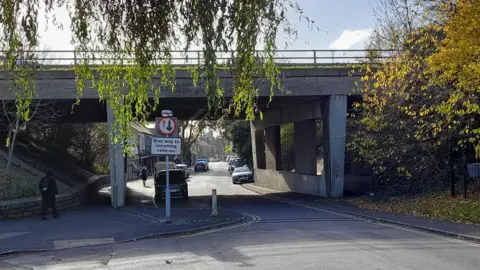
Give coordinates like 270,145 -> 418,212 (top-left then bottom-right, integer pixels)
294,120 -> 317,175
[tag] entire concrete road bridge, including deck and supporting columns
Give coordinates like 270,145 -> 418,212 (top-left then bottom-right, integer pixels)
0,49 -> 386,207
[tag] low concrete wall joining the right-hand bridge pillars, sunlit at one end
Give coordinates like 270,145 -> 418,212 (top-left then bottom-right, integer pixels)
255,169 -> 327,196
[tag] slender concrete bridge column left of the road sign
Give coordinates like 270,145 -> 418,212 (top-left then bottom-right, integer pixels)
107,105 -> 127,208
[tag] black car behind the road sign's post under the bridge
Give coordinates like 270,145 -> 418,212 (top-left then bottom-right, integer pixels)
155,169 -> 188,200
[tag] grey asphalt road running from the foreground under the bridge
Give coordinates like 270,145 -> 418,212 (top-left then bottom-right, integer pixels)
0,163 -> 480,270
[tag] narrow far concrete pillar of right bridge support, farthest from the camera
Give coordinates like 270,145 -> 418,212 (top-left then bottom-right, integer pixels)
265,126 -> 282,171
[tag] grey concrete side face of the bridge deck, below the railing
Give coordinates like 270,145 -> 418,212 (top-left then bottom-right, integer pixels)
0,68 -> 362,100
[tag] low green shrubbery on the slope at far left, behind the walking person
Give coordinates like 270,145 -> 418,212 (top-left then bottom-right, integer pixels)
0,158 -> 40,201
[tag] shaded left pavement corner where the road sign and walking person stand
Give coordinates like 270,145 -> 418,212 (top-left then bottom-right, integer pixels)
0,171 -> 245,255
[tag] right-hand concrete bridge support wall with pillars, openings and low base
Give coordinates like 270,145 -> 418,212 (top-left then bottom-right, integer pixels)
251,95 -> 347,197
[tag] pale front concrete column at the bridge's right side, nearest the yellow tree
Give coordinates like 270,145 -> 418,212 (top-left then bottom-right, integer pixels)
322,95 -> 347,197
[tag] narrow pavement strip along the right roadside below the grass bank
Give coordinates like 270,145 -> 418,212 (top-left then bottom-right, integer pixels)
243,184 -> 480,243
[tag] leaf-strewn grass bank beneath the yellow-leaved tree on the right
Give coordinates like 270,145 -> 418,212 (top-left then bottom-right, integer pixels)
347,193 -> 480,225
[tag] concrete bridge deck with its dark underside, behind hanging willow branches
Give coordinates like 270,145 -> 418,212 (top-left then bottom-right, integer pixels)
0,67 -> 361,123
